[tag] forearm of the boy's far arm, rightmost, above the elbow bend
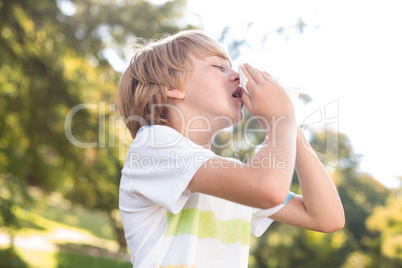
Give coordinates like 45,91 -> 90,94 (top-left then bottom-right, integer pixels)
295,128 -> 344,230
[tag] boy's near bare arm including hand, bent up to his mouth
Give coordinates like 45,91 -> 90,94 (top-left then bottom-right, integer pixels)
188,63 -> 296,208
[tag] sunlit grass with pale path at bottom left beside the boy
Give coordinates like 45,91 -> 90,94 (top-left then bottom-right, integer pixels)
0,187 -> 132,268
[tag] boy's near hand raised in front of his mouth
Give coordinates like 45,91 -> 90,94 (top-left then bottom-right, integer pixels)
241,64 -> 295,126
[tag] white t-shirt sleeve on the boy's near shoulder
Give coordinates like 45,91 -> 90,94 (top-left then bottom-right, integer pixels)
122,127 -> 216,214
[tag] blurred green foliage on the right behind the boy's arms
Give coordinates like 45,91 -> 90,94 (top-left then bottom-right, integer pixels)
213,113 -> 396,268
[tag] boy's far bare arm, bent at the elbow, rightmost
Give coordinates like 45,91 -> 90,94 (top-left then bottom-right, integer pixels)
271,128 -> 345,232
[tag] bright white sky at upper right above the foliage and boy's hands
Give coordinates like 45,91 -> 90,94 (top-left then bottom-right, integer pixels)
186,0 -> 402,187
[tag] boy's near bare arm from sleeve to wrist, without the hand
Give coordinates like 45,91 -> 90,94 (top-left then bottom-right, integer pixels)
188,118 -> 296,209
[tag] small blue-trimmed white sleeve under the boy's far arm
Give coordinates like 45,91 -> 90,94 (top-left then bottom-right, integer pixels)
251,192 -> 295,237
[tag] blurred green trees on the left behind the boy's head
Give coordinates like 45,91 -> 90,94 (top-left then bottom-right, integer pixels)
0,0 -> 195,253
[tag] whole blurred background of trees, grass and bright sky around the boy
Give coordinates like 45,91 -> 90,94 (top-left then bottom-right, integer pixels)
0,0 -> 402,268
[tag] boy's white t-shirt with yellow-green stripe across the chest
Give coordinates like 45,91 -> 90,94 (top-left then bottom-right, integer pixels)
119,125 -> 294,268
